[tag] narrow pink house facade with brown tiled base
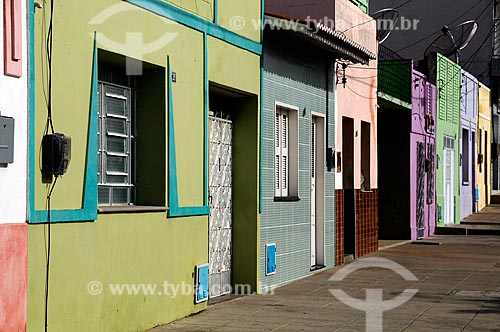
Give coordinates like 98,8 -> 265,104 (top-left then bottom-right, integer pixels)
335,0 -> 379,265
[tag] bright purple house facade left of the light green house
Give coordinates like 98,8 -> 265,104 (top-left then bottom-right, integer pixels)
410,70 -> 437,240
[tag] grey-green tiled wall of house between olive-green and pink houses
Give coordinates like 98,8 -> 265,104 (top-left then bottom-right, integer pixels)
260,42 -> 335,292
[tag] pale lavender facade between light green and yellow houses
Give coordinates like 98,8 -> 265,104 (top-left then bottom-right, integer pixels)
460,71 -> 479,220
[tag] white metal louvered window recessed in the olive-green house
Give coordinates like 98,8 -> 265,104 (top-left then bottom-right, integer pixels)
98,83 -> 135,206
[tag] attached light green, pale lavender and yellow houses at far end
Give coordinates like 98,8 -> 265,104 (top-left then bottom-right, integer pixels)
420,54 -> 492,226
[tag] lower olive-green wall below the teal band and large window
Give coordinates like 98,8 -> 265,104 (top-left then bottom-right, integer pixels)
27,213 -> 208,332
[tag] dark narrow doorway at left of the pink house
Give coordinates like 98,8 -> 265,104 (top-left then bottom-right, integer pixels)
342,117 -> 356,261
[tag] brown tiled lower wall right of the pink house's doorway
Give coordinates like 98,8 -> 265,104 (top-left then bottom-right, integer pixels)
356,189 -> 378,258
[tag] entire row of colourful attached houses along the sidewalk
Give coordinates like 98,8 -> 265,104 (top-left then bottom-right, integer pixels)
0,0 -> 491,332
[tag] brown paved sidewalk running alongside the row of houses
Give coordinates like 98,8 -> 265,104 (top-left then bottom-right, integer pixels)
150,236 -> 500,332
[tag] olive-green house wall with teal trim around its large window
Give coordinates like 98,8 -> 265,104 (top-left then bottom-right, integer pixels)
27,0 -> 261,332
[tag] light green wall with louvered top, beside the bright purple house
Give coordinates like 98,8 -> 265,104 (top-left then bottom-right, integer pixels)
430,54 -> 462,225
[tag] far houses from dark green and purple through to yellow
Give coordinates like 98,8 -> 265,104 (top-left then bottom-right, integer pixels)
378,47 -> 492,240
